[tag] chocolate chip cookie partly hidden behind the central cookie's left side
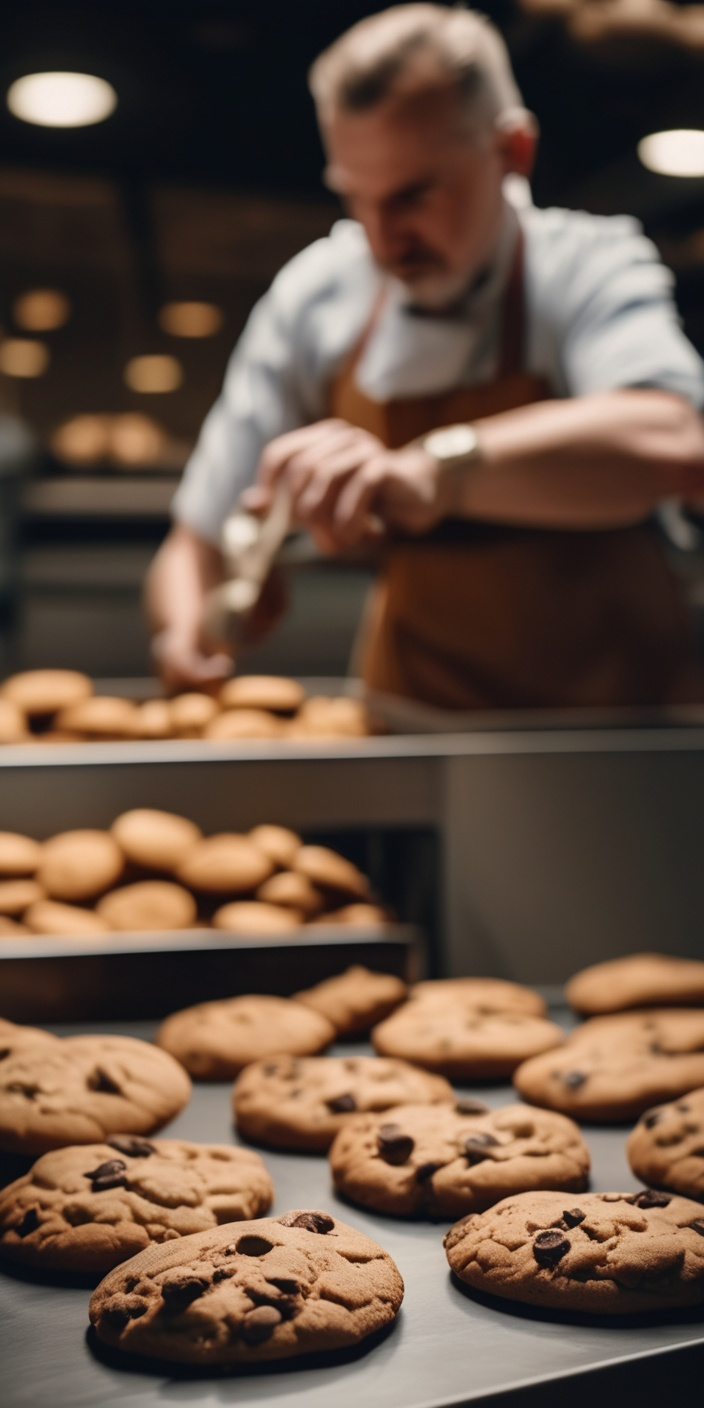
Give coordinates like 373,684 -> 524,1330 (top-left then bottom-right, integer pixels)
232,1056 -> 455,1153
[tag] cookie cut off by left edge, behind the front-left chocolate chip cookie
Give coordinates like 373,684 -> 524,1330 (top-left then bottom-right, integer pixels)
0,1035 -> 190,1153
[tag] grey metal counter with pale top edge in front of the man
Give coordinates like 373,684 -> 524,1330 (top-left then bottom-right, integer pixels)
0,718 -> 704,983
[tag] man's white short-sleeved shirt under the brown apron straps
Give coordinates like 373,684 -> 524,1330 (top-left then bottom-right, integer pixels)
172,207 -> 704,543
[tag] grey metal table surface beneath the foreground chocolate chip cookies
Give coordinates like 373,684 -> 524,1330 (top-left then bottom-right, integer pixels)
0,1024 -> 704,1408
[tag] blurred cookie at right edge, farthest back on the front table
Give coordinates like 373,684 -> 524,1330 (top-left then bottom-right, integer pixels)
565,953 -> 704,1017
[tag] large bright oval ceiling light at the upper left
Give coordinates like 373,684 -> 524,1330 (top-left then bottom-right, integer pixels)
7,73 -> 117,127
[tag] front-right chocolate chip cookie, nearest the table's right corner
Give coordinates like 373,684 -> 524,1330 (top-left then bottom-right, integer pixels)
445,1191 -> 704,1315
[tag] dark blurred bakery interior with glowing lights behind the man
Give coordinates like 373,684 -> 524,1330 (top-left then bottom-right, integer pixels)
0,0 -> 704,677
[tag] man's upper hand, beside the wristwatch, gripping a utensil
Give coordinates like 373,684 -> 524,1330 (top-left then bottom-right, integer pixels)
244,420 -> 452,552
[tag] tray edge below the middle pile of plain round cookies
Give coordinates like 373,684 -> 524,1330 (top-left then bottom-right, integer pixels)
0,924 -> 413,1024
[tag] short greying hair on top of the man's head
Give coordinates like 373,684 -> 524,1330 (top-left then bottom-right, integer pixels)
308,4 -> 522,131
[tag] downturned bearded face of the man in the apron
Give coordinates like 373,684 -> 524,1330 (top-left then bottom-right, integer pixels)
322,89 -> 507,308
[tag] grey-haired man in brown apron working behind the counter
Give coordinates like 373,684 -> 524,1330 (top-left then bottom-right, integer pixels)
148,4 -> 704,708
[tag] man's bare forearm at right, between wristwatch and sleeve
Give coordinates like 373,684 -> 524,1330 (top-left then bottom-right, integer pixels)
448,390 -> 704,528
